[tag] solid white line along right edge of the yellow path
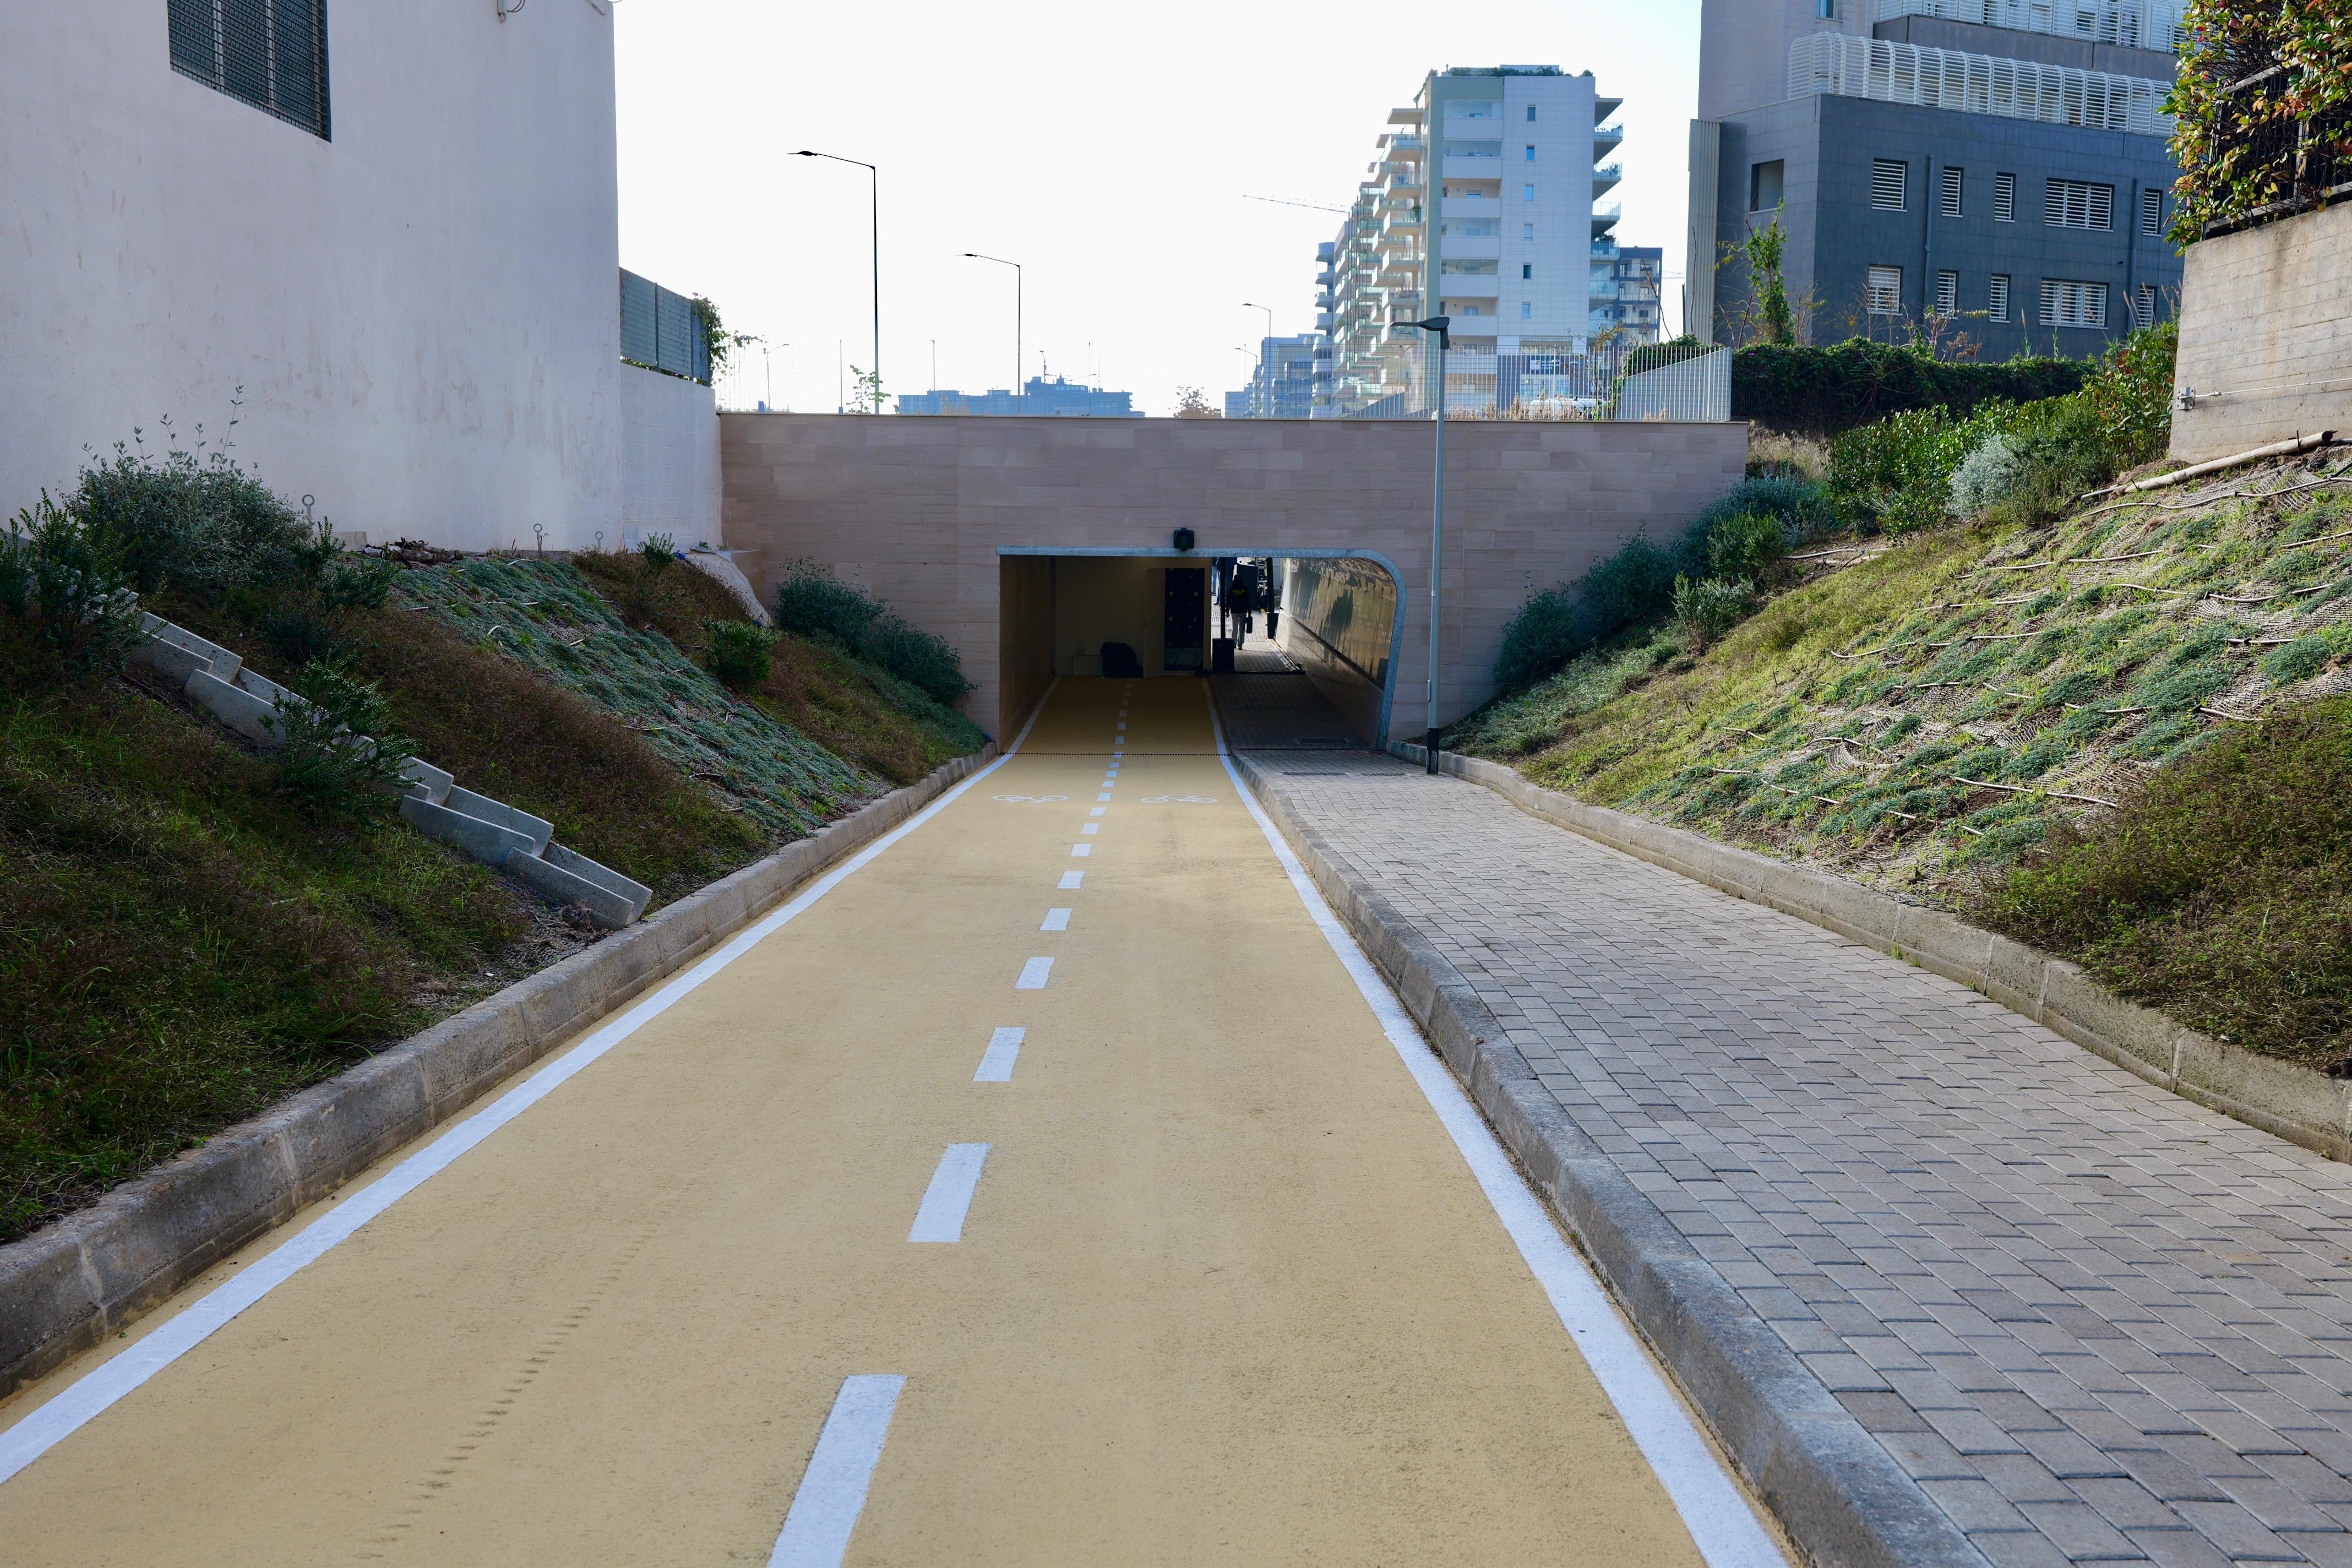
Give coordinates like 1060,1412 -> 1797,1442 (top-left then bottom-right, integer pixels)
1202,691 -> 1788,1568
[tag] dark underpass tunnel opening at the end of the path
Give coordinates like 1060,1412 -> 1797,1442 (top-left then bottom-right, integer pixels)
997,548 -> 1400,750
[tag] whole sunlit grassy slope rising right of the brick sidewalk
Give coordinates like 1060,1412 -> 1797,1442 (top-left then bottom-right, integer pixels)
1453,454 -> 2352,1055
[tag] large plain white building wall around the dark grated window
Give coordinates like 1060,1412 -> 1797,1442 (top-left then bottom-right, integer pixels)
0,0 -> 620,548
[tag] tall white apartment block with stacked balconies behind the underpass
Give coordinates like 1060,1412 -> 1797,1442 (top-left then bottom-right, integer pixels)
1315,66 -> 1623,418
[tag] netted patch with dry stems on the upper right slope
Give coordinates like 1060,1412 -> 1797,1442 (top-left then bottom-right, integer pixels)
1630,470 -> 2352,858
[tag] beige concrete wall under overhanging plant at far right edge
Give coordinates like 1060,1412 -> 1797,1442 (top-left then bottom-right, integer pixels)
2173,204 -> 2352,463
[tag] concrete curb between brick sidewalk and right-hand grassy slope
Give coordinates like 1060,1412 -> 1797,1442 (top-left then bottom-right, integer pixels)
1390,743 -> 2352,1161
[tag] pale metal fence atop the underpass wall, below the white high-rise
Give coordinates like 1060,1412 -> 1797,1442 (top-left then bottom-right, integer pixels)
1315,334 -> 1731,423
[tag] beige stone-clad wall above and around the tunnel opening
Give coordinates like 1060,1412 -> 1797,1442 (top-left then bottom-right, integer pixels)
720,413 -> 1747,736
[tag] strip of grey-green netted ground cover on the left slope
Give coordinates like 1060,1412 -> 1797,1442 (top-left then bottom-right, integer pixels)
400,559 -> 889,839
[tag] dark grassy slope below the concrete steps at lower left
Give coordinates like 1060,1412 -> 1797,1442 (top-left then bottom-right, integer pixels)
0,623 -> 529,1241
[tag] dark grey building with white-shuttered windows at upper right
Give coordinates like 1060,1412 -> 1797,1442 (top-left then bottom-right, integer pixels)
1684,0 -> 2182,360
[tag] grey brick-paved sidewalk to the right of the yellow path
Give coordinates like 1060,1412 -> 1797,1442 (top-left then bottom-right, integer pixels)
1259,755 -> 2352,1566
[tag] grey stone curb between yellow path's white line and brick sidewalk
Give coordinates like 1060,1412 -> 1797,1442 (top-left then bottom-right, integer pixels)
1235,755 -> 1985,1568
